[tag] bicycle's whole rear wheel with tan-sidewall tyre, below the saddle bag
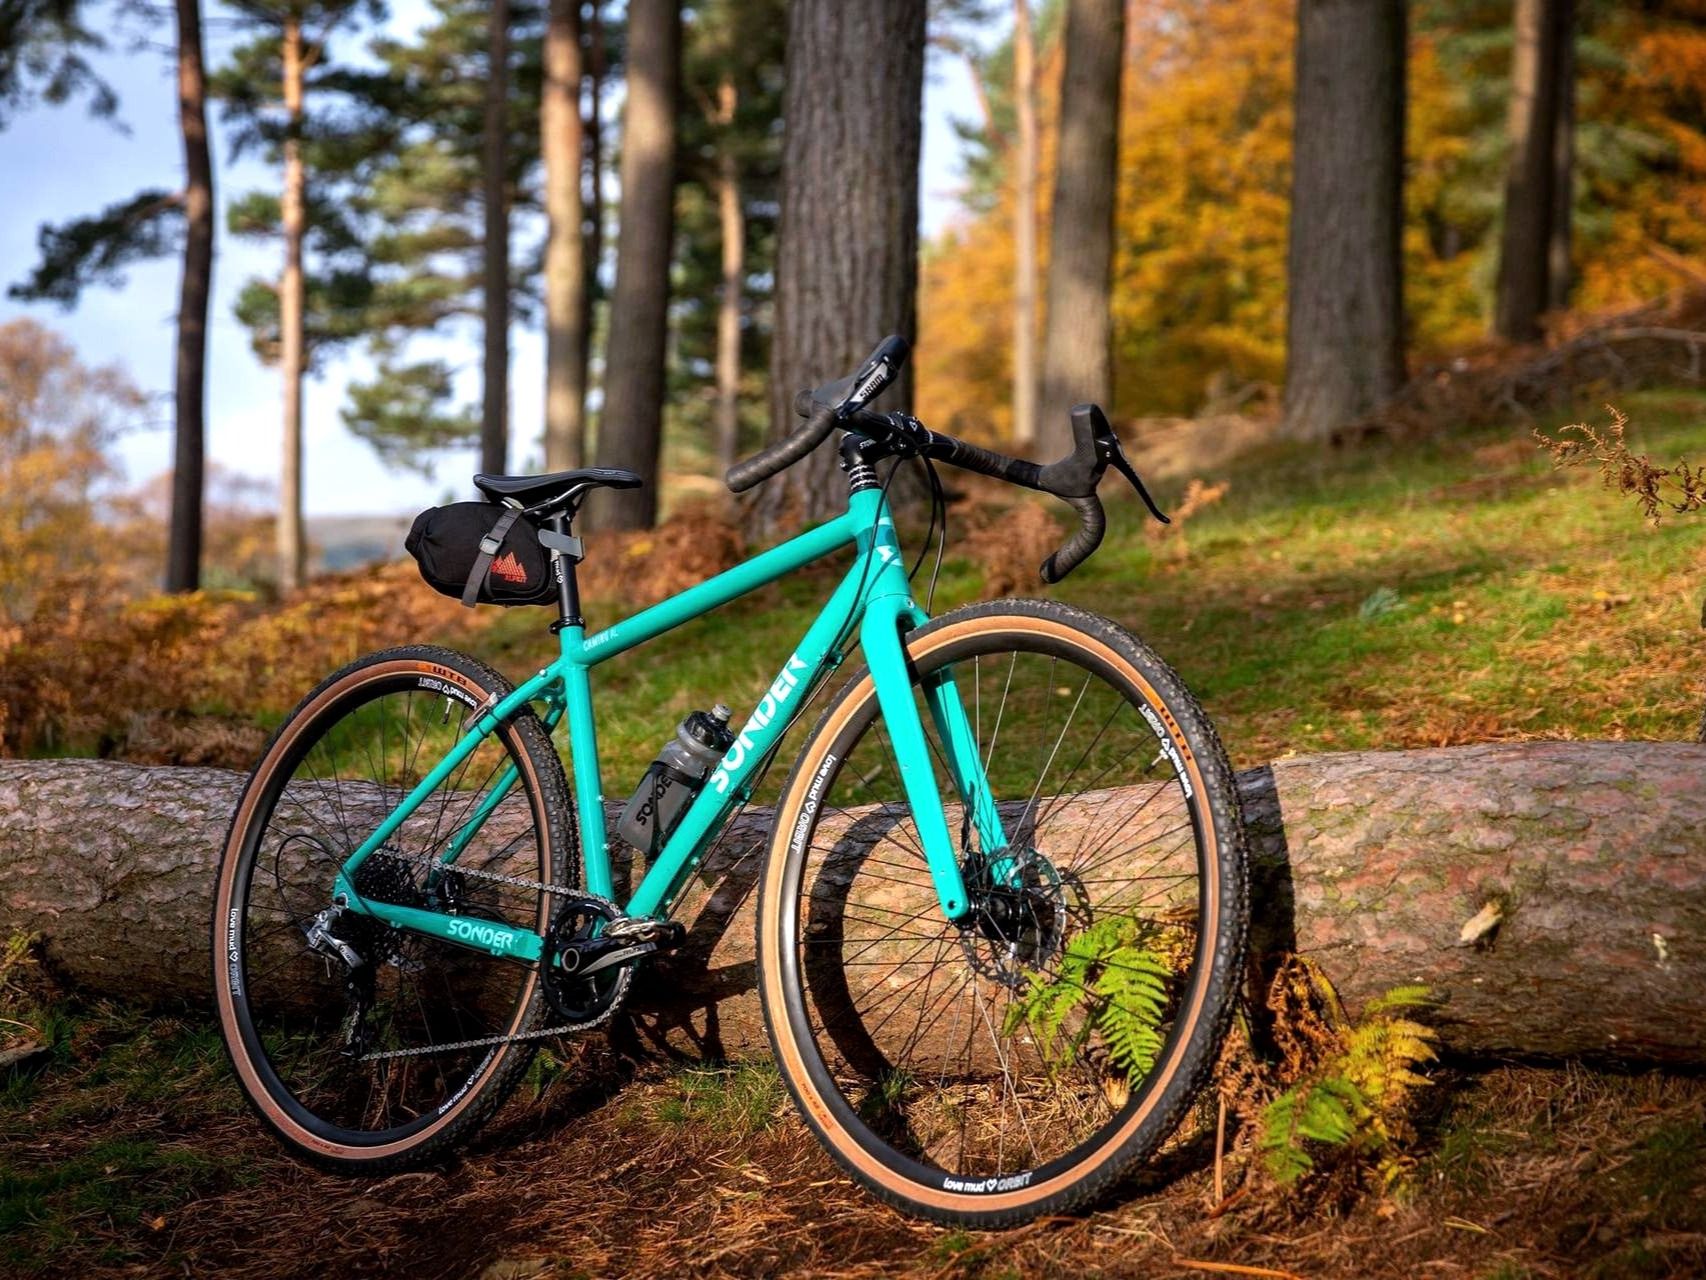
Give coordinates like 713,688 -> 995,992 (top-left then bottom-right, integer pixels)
213,647 -> 577,1172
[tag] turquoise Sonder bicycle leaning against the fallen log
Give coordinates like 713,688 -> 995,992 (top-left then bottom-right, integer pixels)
213,338 -> 1247,1227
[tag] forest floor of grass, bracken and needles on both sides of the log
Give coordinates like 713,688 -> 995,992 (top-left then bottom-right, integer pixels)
10,391 -> 1706,1280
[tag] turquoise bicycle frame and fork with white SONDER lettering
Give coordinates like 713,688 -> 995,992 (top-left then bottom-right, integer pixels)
333,488 -> 1007,961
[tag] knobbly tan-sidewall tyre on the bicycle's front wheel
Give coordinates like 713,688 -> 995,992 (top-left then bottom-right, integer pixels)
757,601 -> 1244,1225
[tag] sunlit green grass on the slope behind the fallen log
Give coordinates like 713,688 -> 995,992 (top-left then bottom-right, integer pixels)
457,391 -> 1706,781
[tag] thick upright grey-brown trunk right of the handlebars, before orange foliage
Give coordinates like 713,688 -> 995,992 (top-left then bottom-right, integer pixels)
1285,0 -> 1404,440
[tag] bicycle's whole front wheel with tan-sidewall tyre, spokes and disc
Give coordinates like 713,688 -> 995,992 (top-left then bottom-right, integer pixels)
759,601 -> 1249,1227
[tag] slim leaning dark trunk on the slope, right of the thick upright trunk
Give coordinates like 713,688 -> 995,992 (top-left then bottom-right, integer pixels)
1493,0 -> 1561,343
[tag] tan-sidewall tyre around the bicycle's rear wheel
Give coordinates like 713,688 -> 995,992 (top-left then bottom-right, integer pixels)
213,650 -> 554,1169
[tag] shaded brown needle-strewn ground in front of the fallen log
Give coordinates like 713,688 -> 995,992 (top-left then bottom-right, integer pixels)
0,1004 -> 1706,1280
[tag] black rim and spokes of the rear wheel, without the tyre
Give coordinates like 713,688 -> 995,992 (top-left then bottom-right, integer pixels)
225,671 -> 548,1147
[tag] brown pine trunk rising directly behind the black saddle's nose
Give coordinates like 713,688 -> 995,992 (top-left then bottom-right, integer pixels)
587,0 -> 681,529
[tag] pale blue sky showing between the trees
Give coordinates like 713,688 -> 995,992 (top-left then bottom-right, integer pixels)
0,0 -> 974,515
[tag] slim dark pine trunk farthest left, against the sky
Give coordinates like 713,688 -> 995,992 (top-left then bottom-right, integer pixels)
165,0 -> 213,591
